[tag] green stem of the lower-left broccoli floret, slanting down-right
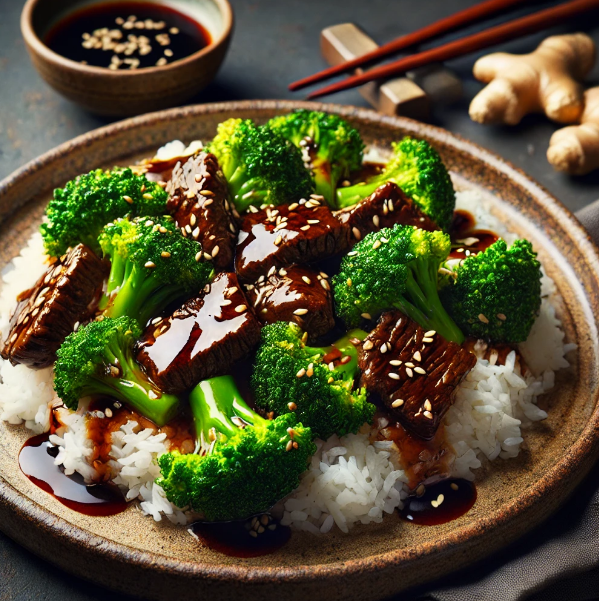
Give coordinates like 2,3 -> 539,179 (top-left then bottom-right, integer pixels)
93,336 -> 179,427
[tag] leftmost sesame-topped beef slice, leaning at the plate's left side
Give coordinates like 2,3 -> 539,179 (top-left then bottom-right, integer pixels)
1,244 -> 109,368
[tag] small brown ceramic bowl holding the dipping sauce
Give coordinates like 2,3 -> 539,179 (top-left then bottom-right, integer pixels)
21,0 -> 233,116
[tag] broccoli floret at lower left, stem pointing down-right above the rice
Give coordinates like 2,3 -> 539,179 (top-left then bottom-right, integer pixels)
54,317 -> 179,426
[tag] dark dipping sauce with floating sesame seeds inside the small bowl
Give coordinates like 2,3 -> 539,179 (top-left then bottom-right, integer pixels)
44,2 -> 211,71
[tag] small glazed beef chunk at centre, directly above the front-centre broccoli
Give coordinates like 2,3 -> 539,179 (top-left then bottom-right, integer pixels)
246,265 -> 335,339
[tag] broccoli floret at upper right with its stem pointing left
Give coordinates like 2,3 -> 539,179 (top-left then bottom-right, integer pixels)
337,138 -> 455,231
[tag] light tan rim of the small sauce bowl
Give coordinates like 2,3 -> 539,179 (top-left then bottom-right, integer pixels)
21,0 -> 234,79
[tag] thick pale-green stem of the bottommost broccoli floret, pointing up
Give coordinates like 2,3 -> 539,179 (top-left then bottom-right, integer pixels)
189,376 -> 267,446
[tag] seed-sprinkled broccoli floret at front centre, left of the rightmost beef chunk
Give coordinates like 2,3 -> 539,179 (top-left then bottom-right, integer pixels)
251,321 -> 375,440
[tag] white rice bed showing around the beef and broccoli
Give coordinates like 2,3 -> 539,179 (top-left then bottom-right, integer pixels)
0,189 -> 575,534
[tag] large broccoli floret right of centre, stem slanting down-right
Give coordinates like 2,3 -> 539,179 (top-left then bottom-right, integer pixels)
333,224 -> 464,343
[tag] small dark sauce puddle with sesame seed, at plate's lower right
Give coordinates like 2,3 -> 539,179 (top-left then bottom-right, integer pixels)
399,478 -> 476,526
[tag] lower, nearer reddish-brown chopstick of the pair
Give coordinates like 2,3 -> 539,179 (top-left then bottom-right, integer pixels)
308,0 -> 599,99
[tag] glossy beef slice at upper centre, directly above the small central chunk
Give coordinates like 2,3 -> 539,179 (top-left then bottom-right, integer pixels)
235,197 -> 349,283
